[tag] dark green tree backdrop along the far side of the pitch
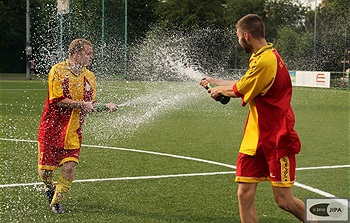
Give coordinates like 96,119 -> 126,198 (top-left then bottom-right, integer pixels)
0,0 -> 350,73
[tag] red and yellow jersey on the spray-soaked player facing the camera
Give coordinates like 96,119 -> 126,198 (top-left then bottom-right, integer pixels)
38,60 -> 96,149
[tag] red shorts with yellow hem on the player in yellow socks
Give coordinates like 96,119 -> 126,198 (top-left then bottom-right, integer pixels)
38,143 -> 80,170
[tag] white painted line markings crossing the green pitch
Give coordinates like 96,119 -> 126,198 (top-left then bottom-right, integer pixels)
0,138 -> 350,197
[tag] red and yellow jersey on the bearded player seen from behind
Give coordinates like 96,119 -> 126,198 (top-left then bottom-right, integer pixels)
233,43 -> 301,158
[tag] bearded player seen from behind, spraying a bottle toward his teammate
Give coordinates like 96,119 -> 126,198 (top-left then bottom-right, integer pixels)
200,14 -> 305,222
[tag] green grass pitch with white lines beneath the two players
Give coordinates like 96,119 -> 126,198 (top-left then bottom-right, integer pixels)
0,80 -> 350,223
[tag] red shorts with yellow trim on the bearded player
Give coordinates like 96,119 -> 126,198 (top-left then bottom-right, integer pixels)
235,149 -> 296,187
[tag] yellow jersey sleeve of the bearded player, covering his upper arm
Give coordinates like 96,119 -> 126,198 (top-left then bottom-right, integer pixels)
233,53 -> 277,106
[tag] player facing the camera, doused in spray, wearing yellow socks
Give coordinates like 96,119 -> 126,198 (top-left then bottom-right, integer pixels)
38,39 -> 117,214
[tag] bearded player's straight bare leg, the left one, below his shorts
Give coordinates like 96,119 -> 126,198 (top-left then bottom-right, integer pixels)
237,183 -> 258,223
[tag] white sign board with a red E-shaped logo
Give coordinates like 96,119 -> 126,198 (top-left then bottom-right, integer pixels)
295,71 -> 331,88
